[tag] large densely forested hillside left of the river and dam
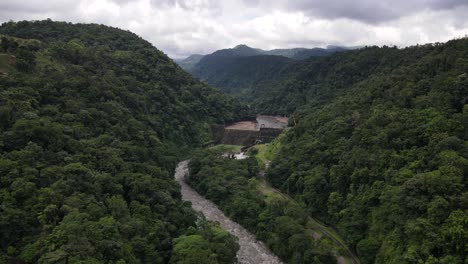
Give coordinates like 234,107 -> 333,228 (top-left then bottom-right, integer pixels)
0,20 -> 246,263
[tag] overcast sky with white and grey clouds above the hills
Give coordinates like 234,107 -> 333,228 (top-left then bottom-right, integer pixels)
0,0 -> 468,58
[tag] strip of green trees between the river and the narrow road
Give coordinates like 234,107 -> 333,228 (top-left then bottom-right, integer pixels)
187,150 -> 336,263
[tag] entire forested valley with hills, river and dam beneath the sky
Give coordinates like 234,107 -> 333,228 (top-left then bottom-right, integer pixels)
0,19 -> 468,264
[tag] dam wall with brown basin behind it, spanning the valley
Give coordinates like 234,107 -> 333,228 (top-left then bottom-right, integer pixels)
220,115 -> 288,146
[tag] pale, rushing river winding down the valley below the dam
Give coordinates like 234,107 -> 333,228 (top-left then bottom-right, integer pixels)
175,161 -> 283,264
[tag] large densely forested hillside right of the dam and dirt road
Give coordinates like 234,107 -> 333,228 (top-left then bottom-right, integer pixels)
264,38 -> 468,264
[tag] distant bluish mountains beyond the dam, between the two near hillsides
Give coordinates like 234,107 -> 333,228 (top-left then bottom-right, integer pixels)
176,44 -> 350,94
